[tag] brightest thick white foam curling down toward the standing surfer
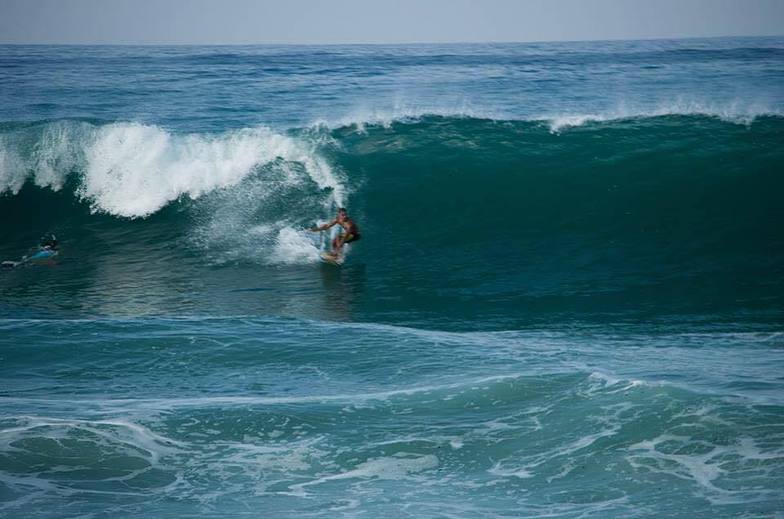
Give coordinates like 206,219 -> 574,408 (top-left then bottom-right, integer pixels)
79,123 -> 342,217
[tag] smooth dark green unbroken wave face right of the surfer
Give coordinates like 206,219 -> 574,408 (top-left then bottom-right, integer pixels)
324,116 -> 784,322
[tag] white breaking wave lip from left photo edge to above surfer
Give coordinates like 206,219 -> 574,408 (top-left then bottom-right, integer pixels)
0,121 -> 344,218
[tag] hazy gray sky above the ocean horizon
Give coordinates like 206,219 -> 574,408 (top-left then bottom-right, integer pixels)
0,0 -> 784,43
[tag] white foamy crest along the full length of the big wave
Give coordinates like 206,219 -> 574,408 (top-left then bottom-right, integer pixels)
0,100 -> 784,218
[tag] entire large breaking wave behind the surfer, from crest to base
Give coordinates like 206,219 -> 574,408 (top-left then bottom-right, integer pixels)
0,115 -> 784,327
